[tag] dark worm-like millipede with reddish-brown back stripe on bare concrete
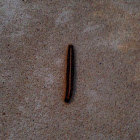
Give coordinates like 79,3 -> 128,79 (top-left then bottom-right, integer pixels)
65,45 -> 74,103
